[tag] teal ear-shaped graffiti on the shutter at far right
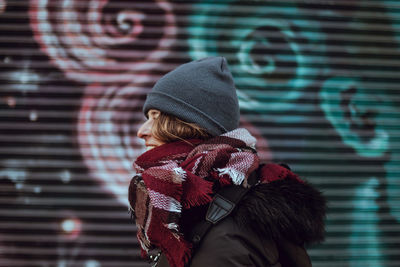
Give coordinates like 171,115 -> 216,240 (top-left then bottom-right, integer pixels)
319,77 -> 389,157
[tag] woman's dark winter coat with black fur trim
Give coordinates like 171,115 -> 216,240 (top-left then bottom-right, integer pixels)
157,174 -> 325,267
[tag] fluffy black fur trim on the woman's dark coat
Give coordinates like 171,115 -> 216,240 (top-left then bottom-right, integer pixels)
234,179 -> 326,244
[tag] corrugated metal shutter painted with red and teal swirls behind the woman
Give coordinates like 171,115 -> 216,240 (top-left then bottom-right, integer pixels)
0,0 -> 400,267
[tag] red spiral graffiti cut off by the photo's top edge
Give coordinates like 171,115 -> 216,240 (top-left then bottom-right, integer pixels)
30,0 -> 177,83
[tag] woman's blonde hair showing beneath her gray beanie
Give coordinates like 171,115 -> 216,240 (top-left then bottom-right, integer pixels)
152,112 -> 212,143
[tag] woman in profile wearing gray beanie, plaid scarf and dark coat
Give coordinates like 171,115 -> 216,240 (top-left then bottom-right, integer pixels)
129,57 -> 325,267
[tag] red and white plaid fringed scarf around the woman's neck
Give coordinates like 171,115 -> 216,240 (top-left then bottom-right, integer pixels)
129,129 -> 300,267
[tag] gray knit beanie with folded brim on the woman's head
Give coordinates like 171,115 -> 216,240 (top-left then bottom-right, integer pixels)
143,57 -> 240,136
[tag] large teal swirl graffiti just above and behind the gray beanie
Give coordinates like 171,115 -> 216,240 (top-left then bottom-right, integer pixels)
188,1 -> 325,112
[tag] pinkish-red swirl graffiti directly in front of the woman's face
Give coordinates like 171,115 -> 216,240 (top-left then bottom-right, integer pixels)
78,81 -> 153,205
